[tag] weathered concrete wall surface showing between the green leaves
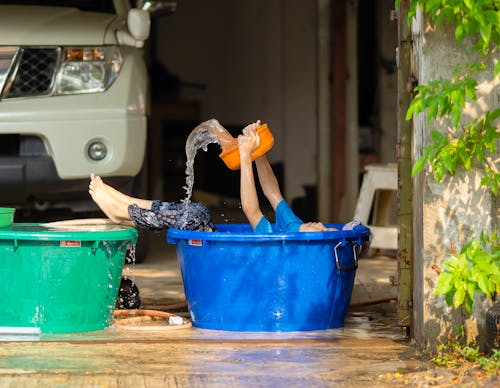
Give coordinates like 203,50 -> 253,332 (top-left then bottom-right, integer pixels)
413,9 -> 500,349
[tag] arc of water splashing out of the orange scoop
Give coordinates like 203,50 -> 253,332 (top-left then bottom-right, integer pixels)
181,119 -> 234,204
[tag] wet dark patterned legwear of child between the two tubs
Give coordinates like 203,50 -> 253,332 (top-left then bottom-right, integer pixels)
128,201 -> 215,232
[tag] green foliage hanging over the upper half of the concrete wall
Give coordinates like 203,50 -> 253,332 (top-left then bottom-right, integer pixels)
396,0 -> 500,195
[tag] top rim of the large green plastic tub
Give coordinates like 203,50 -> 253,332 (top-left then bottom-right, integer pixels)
0,223 -> 138,241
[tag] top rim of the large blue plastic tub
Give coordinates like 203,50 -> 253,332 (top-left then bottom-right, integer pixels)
167,224 -> 371,244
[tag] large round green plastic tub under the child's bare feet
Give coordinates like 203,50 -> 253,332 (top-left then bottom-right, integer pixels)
0,223 -> 137,333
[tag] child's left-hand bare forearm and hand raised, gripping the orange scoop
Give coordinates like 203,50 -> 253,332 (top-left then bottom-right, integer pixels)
238,124 -> 263,229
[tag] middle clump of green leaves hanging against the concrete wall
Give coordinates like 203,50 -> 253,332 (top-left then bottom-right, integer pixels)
406,63 -> 500,195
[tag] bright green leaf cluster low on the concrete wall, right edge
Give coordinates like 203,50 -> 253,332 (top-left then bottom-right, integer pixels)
435,231 -> 500,314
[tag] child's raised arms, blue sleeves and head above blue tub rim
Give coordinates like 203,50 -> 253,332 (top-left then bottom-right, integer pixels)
238,121 -> 337,233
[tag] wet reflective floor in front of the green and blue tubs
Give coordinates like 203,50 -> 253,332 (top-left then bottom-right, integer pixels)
0,303 -> 428,387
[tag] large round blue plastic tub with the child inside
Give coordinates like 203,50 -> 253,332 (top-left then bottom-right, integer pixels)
167,224 -> 370,331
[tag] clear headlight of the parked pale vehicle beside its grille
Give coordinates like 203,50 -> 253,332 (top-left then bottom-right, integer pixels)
54,46 -> 123,95
